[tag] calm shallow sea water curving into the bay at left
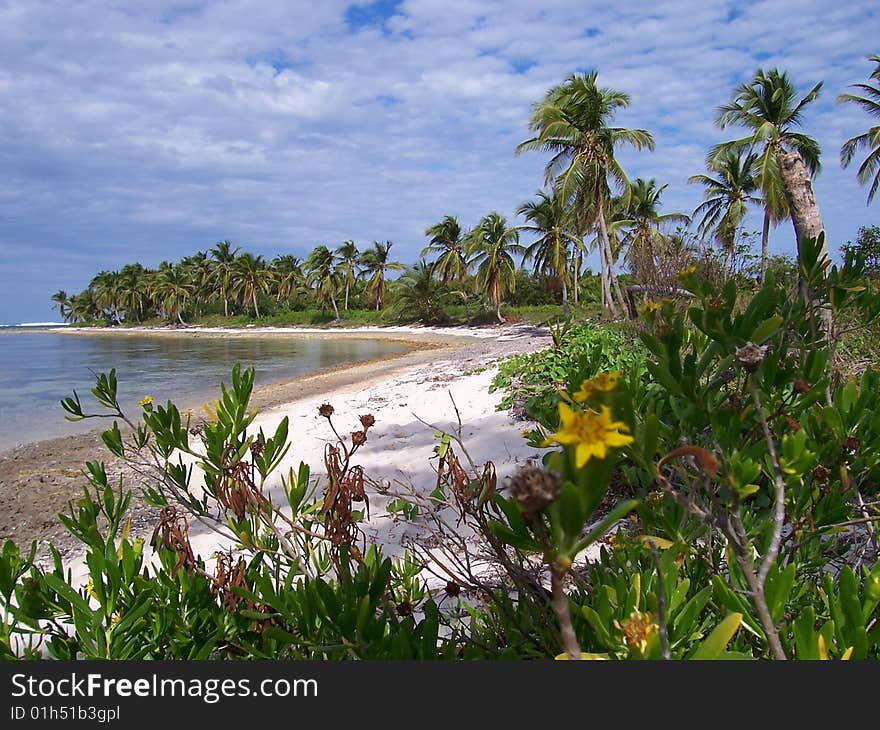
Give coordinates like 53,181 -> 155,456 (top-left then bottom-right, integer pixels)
0,328 -> 407,450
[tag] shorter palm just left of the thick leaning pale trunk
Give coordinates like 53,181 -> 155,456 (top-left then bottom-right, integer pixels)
688,147 -> 769,281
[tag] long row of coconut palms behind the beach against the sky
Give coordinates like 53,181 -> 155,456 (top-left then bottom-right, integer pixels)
52,55 -> 880,324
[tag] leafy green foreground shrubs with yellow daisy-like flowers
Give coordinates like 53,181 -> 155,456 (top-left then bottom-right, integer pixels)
0,228 -> 880,660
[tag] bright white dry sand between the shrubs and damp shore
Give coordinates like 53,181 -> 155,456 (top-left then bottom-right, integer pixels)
73,326 -> 548,581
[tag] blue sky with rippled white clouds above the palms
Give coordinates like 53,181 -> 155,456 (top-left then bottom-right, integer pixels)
0,0 -> 880,324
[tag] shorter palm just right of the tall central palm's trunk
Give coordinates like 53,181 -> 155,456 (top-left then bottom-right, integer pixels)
620,177 -> 690,284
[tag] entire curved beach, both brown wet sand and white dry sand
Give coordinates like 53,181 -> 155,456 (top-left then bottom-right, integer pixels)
0,325 -> 549,561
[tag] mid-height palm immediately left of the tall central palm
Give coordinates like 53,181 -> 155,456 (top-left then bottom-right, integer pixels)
516,190 -> 579,317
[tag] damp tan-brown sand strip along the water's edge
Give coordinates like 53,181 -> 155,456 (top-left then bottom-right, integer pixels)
0,325 -> 546,559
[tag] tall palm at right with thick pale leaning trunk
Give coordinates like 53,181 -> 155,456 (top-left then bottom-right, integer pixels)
716,69 -> 828,264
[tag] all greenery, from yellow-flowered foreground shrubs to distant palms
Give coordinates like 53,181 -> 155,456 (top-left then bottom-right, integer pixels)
17,56 -> 880,660
